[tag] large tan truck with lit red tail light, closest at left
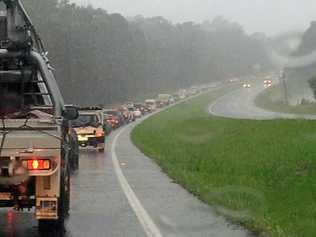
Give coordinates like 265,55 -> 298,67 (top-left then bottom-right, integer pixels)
0,0 -> 78,226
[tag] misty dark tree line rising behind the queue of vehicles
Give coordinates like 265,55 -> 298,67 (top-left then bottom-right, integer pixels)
23,0 -> 269,105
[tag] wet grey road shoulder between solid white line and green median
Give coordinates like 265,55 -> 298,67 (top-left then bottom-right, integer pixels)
111,113 -> 250,237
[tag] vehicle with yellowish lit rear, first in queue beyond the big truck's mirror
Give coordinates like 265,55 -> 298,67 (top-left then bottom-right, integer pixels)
72,107 -> 105,152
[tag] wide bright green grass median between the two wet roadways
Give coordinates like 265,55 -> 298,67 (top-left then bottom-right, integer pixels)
132,90 -> 316,237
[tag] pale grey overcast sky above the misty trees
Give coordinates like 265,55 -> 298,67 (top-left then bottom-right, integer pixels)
73,0 -> 316,35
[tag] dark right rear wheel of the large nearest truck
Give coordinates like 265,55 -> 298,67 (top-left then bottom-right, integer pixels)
38,166 -> 70,230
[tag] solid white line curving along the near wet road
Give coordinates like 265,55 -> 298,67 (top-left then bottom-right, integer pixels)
111,127 -> 162,237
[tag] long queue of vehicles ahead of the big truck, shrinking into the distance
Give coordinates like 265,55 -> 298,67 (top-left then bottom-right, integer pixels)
72,87 -> 205,156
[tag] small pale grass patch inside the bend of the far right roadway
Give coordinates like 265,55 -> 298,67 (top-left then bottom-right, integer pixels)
255,85 -> 316,114
